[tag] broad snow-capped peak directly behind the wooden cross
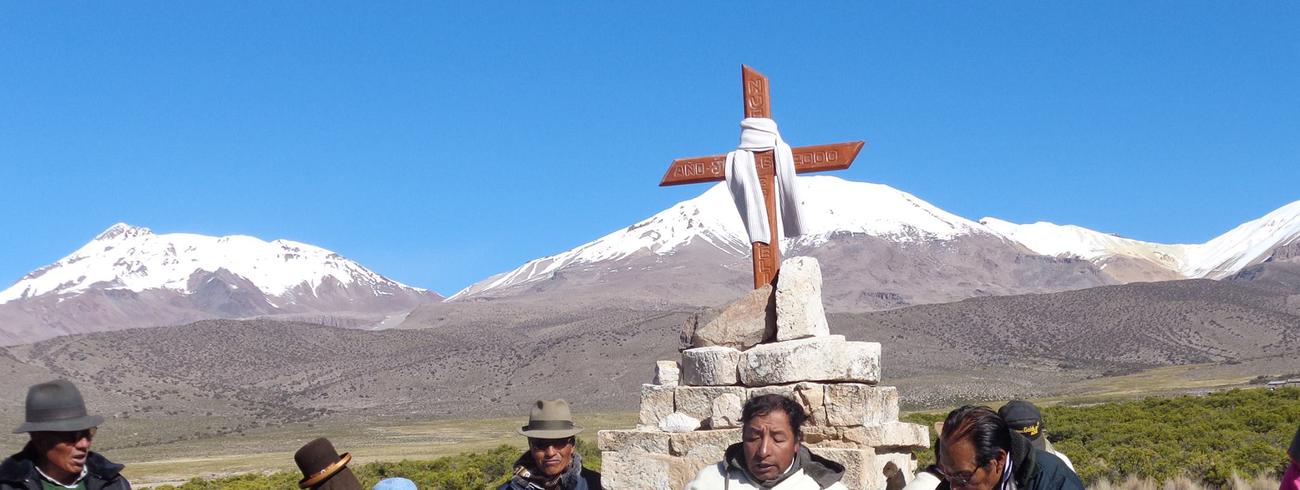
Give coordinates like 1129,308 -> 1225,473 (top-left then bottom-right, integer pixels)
447,175 -> 1114,311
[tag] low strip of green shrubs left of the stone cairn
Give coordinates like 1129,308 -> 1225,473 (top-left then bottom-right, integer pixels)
157,439 -> 601,490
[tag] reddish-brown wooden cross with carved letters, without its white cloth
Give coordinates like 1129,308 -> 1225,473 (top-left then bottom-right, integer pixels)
659,65 -> 865,289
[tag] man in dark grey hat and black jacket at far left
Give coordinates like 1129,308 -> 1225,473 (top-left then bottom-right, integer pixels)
0,380 -> 131,490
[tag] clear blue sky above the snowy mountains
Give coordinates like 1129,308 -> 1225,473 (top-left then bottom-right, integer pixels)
0,1 -> 1300,294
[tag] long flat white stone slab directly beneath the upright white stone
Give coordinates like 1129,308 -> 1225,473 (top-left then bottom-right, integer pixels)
740,335 -> 880,386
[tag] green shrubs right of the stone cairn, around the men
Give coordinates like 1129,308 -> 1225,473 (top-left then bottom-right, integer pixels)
905,389 -> 1300,486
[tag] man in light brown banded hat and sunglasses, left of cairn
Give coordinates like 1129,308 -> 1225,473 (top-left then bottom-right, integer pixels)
498,400 -> 601,490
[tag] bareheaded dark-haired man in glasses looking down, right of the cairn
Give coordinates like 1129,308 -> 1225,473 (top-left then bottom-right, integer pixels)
936,406 -> 1083,490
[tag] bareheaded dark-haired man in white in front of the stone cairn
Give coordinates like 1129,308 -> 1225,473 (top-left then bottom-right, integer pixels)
686,395 -> 845,490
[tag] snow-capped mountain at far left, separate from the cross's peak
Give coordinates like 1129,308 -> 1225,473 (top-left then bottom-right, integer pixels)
0,224 -> 441,343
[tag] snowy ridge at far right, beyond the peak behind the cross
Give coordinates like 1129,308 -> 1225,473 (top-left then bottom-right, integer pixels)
980,201 -> 1300,279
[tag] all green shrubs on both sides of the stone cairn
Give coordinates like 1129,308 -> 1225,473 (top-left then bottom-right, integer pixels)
160,387 -> 1300,490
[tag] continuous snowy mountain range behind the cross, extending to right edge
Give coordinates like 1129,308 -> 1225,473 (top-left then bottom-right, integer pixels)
447,175 -> 1300,309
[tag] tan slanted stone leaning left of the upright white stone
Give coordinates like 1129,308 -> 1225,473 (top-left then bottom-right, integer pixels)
690,286 -> 776,350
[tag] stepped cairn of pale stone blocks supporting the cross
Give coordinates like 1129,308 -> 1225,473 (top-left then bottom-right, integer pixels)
597,257 -> 930,490
